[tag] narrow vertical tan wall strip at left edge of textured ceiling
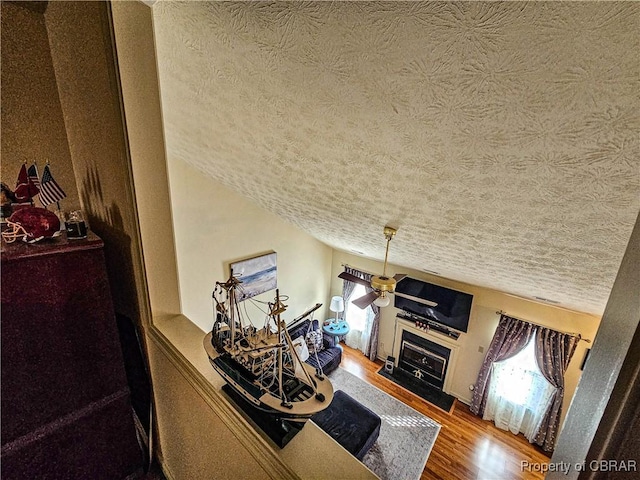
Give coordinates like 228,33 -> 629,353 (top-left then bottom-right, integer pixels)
111,2 -> 180,321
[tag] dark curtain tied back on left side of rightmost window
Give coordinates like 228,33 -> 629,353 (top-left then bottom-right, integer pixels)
469,315 -> 536,416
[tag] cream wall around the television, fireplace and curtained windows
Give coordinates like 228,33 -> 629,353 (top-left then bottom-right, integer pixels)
330,249 -> 600,414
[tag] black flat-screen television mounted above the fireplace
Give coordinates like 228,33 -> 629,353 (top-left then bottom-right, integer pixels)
394,277 -> 473,332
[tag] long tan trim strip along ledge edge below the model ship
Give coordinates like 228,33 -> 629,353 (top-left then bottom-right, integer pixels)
147,326 -> 300,480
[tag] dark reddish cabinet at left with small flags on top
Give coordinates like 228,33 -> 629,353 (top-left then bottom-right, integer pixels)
1,233 -> 142,480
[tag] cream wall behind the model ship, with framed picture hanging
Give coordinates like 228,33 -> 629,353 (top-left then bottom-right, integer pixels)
168,158 -> 332,332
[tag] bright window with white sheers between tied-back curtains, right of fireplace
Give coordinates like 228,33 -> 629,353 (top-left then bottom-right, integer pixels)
483,335 -> 555,441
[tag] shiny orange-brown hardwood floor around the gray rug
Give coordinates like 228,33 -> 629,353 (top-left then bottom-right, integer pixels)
340,344 -> 549,480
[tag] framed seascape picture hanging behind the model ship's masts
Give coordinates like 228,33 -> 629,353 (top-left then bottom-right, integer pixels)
229,252 -> 278,302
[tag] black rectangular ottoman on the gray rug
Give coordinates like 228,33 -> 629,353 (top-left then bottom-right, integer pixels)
311,390 -> 382,460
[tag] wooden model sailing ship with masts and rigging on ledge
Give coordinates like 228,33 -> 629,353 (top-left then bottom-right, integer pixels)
204,272 -> 333,428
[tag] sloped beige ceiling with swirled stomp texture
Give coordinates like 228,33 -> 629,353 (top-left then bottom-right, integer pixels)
153,1 -> 640,314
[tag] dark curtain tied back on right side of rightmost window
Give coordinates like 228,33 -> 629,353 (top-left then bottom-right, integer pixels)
535,327 -> 580,452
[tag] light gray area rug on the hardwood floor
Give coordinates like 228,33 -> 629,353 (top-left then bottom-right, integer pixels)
329,368 -> 440,480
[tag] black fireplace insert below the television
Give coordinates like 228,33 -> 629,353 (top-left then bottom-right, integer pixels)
398,330 -> 451,390
